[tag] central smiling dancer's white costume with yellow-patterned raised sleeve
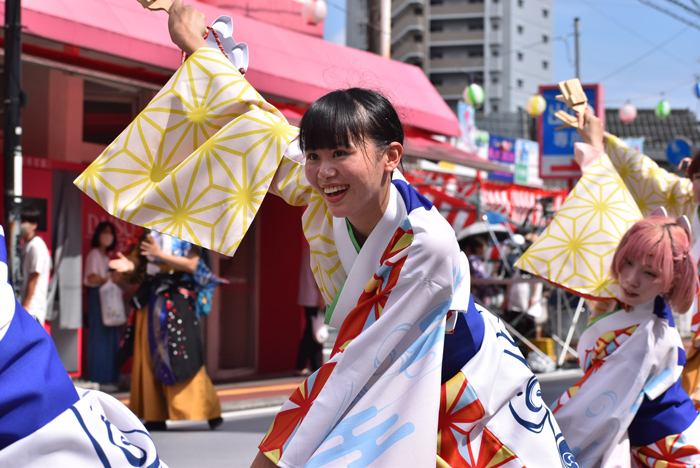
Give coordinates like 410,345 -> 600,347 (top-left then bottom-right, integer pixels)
76,49 -> 575,468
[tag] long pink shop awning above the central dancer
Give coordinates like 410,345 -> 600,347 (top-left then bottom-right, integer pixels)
12,0 -> 459,136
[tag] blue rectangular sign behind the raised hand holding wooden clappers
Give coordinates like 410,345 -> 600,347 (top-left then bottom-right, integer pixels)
537,84 -> 605,179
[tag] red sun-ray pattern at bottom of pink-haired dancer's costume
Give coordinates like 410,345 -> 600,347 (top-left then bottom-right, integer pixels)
632,434 -> 700,468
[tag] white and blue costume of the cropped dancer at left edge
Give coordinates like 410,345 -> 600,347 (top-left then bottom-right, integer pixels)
0,227 -> 167,468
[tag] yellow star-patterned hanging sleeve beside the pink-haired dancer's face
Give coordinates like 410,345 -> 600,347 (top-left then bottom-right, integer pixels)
515,155 -> 642,299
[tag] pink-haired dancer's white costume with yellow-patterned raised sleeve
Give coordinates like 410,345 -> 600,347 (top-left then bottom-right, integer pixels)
516,143 -> 700,468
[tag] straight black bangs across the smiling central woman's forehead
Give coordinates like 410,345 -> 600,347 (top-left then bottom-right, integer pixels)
299,90 -> 365,152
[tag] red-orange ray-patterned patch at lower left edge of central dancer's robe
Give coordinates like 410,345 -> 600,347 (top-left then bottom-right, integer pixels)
260,362 -> 336,461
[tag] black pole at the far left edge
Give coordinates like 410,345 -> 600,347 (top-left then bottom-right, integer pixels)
3,0 -> 25,296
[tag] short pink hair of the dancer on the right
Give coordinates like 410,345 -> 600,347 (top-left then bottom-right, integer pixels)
610,216 -> 698,314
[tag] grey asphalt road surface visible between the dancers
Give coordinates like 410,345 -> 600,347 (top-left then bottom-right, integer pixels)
152,371 -> 581,468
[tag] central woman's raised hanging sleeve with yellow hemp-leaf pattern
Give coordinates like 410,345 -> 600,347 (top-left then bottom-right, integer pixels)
75,49 -> 298,255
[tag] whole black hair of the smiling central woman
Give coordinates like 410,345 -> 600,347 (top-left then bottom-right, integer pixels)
299,88 -> 404,157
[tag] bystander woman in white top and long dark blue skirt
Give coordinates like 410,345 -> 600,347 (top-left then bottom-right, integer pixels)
84,221 -> 119,390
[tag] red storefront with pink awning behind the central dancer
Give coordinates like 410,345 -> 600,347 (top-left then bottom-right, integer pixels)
1,0 -> 504,380
